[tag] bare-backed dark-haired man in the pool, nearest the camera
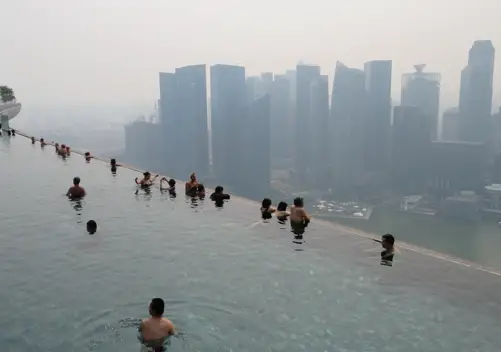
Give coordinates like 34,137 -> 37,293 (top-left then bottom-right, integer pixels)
139,298 -> 176,351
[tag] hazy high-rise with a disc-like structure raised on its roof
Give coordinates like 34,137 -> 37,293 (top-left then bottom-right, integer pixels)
400,65 -> 440,140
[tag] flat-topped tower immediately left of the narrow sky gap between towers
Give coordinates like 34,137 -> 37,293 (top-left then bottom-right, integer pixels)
172,65 -> 209,178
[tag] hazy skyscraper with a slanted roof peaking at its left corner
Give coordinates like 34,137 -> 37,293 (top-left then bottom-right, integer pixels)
329,62 -> 367,193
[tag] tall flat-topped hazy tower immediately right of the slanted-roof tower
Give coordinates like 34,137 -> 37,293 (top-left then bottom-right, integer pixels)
364,60 -> 392,172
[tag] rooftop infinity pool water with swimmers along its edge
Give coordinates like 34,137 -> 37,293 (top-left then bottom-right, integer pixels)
0,136 -> 501,352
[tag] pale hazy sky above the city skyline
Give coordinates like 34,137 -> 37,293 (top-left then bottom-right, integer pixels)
0,0 -> 501,109
